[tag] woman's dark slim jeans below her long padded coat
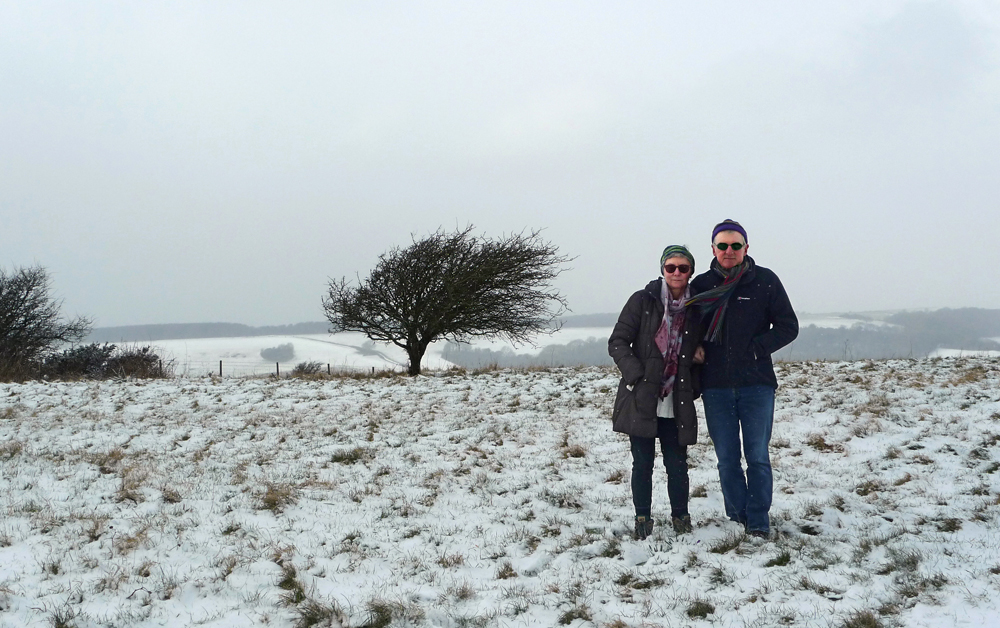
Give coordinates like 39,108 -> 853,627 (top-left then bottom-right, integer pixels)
629,418 -> 688,517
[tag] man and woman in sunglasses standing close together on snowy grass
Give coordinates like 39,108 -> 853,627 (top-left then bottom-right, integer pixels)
608,220 -> 799,539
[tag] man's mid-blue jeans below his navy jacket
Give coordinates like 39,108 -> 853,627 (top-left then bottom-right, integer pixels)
701,386 -> 774,532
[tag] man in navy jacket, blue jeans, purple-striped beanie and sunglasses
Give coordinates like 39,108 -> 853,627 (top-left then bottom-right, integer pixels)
688,220 -> 799,538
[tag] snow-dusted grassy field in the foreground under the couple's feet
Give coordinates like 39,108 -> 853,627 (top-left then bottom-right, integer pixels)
0,358 -> 1000,628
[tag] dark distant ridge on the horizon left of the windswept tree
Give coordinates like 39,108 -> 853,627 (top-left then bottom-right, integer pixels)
84,321 -> 330,343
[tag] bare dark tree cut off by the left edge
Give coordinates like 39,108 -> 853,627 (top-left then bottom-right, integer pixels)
0,266 -> 91,375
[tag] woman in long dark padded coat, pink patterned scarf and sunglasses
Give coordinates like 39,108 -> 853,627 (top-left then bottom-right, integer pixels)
608,245 -> 702,539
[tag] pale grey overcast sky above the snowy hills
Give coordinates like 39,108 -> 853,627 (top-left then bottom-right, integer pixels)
0,0 -> 1000,326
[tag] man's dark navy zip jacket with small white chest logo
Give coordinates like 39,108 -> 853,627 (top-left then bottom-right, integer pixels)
691,260 -> 799,390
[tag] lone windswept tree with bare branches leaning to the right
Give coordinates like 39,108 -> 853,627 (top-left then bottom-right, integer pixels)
323,226 -> 569,375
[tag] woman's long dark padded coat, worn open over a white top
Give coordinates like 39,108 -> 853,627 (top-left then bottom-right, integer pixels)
608,279 -> 700,445
